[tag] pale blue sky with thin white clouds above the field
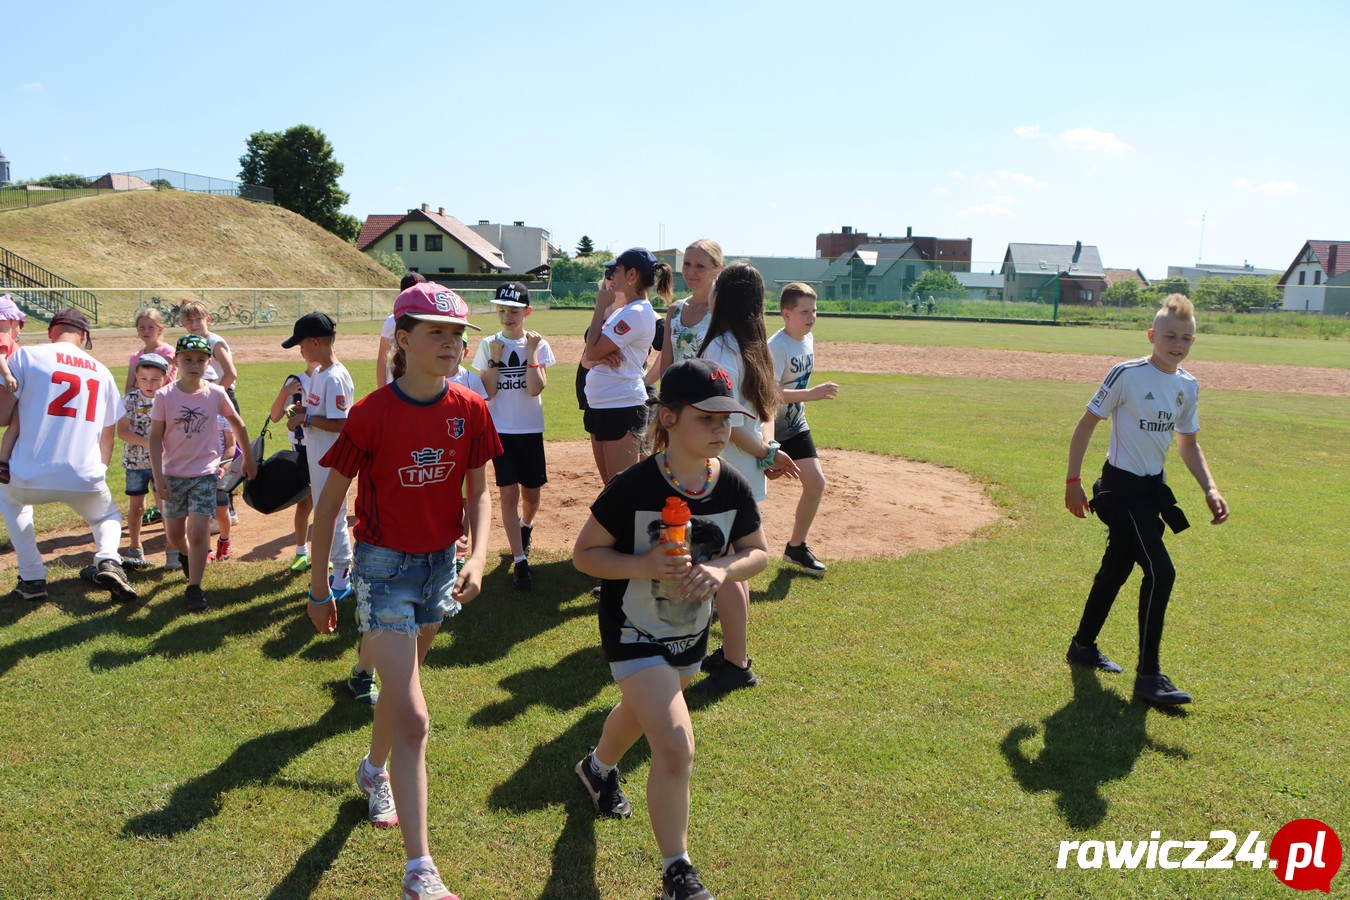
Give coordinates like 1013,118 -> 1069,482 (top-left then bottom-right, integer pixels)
0,0 -> 1350,277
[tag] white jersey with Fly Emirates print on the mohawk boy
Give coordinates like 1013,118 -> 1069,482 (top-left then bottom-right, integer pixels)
1088,356 -> 1200,475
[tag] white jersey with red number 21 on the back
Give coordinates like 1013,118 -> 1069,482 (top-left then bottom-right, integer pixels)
9,341 -> 122,491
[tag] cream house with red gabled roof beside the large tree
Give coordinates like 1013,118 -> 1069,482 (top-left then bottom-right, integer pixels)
356,204 -> 506,278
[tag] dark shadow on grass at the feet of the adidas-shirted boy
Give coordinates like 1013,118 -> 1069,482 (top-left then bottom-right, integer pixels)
427,560 -> 597,668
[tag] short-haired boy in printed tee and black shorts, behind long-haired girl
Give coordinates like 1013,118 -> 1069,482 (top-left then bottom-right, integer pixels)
768,282 -> 840,575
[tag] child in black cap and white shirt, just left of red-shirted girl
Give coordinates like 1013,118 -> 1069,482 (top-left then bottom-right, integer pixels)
281,312 -> 356,599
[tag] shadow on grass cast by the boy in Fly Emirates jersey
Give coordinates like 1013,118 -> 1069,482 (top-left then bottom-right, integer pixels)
999,667 -> 1189,830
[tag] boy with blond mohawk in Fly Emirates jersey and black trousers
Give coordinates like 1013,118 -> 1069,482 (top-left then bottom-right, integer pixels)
1064,294 -> 1229,706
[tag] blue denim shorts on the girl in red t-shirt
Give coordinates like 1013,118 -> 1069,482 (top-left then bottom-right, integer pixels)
351,541 -> 459,634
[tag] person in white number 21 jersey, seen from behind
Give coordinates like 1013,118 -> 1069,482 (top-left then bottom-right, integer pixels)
0,308 -> 136,600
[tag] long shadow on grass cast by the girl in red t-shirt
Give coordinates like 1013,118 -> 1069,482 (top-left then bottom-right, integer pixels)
122,681 -> 370,841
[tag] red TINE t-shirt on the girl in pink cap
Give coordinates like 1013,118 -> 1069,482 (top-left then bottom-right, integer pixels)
320,383 -> 502,553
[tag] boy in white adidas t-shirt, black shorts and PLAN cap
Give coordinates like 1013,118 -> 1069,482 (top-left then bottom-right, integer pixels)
474,281 -> 558,591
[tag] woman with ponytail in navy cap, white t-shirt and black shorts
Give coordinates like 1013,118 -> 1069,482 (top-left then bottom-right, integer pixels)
582,247 -> 674,484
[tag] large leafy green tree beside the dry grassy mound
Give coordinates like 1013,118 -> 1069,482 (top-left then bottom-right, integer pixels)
239,125 -> 360,240
